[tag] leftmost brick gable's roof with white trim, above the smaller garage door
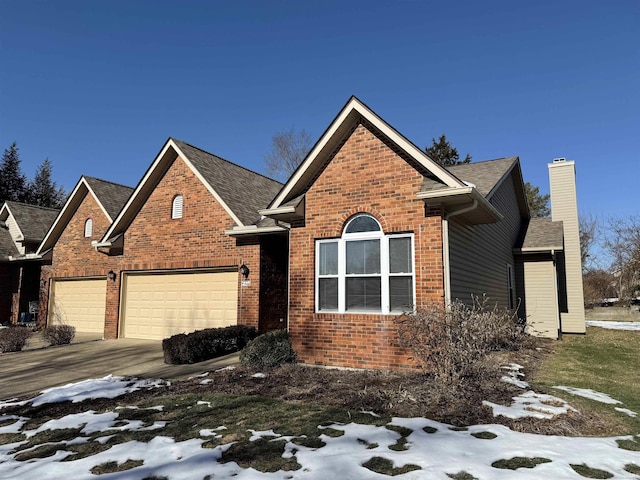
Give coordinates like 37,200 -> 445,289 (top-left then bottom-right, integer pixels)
36,176 -> 133,255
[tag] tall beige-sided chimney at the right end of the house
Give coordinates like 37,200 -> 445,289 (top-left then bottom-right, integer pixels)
549,161 -> 585,333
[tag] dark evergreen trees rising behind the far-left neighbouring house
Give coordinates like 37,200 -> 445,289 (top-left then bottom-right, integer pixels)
0,142 -> 67,208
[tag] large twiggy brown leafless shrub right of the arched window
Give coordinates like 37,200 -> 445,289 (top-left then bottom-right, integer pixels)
397,297 -> 526,383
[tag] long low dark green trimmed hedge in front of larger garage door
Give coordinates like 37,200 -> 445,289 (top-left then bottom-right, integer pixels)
162,325 -> 258,365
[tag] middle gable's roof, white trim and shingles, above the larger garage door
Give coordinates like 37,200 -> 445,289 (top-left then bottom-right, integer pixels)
98,137 -> 282,246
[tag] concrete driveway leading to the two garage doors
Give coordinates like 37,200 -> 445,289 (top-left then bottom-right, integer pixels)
0,334 -> 239,400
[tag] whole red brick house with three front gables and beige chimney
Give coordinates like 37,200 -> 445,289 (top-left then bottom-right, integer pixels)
33,97 -> 585,368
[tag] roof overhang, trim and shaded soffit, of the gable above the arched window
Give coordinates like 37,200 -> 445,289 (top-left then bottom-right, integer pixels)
268,96 -> 465,210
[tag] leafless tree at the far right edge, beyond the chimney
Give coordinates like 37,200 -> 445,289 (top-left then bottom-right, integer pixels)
604,215 -> 640,301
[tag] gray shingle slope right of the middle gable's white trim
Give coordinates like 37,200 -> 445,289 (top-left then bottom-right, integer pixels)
172,138 -> 282,225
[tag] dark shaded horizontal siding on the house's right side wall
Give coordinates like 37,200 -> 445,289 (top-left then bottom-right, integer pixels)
449,172 -> 522,308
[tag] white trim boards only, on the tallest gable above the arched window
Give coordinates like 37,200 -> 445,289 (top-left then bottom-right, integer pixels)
268,97 -> 465,210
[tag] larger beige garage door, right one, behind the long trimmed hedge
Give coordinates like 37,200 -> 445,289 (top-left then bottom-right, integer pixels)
121,271 -> 238,339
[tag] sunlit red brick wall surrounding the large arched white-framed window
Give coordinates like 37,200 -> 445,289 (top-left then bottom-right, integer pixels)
289,125 -> 444,369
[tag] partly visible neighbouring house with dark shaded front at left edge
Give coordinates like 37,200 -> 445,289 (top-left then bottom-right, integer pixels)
0,201 -> 58,324
